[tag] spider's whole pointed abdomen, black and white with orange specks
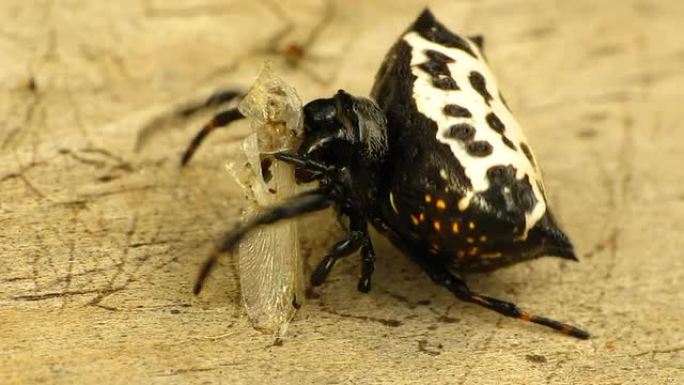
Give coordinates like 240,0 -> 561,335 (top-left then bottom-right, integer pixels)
372,7 -> 574,270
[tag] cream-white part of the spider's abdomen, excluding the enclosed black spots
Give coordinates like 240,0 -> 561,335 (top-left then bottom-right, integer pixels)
403,32 -> 546,239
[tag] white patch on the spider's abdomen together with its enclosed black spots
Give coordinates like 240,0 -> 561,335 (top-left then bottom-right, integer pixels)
403,26 -> 546,237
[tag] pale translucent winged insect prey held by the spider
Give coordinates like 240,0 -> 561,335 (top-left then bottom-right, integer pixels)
231,64 -> 304,337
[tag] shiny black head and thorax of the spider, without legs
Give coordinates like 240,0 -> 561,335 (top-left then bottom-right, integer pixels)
298,90 -> 387,181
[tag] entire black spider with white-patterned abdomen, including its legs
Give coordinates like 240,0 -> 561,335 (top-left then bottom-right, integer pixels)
183,10 -> 589,338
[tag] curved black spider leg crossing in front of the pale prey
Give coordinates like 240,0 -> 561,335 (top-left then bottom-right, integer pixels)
193,189 -> 333,294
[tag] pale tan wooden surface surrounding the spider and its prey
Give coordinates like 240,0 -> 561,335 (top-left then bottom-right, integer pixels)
0,0 -> 684,384
